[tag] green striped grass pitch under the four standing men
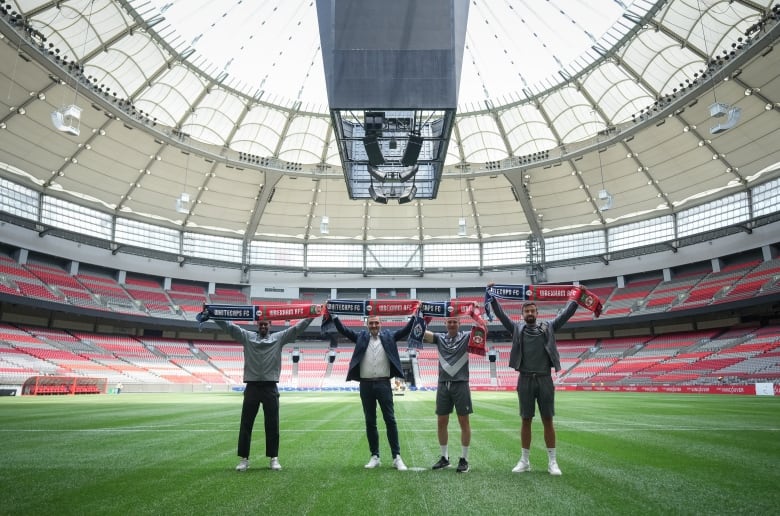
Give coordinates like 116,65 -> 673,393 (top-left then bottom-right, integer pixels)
0,392 -> 780,515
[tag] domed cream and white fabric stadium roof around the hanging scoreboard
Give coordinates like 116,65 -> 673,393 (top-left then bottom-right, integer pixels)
0,0 -> 780,248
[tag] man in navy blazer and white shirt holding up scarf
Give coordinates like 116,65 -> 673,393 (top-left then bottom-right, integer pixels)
333,315 -> 414,471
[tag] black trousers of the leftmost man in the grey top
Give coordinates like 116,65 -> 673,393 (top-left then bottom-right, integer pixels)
238,382 -> 279,458
